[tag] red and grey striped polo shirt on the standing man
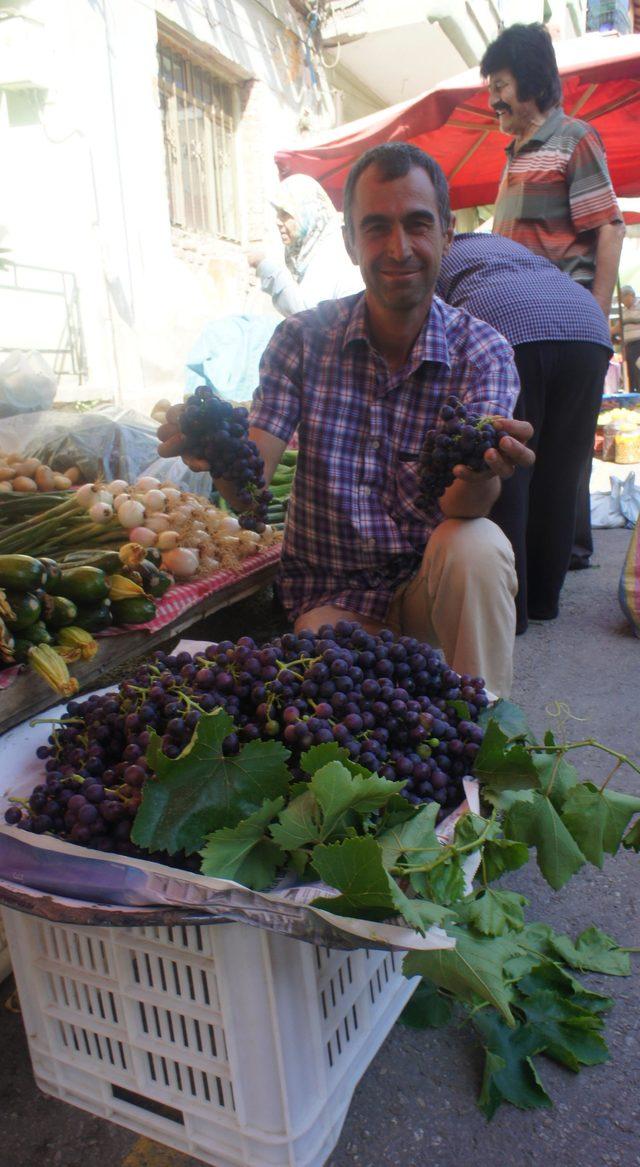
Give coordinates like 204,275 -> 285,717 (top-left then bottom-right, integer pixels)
493,109 -> 621,285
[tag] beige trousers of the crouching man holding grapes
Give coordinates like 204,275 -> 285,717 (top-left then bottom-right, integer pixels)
295,518 -> 517,697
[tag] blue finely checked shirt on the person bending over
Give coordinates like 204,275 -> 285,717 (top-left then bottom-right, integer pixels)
436,233 -> 611,350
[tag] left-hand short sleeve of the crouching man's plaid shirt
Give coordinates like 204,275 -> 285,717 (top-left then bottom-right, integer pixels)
249,316 -> 304,442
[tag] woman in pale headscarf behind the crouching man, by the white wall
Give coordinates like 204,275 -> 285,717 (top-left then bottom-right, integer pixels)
248,174 -> 363,316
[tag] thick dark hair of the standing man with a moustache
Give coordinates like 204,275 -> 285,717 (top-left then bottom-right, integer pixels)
480,25 -> 562,113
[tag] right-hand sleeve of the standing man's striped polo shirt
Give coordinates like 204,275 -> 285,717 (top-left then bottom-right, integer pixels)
566,132 -> 622,235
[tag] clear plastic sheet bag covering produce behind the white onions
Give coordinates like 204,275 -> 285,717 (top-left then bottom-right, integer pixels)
0,406 -> 158,482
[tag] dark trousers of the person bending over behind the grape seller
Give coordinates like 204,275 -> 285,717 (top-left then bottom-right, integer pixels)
491,341 -> 608,631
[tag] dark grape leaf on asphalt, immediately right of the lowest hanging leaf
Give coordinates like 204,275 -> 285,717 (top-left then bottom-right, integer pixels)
520,990 -> 608,1072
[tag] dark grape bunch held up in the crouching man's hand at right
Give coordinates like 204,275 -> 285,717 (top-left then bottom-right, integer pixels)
417,397 -> 502,510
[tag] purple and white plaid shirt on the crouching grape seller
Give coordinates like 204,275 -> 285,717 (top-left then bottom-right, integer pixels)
251,295 -> 520,620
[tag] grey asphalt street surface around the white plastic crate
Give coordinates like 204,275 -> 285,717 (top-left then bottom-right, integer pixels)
0,530 -> 640,1167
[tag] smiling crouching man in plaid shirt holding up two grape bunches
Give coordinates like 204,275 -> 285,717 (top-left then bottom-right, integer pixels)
159,144 -> 534,696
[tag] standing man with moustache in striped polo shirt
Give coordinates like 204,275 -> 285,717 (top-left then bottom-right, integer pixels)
480,23 -> 625,567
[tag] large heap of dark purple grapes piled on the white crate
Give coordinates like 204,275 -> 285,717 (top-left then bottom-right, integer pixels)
5,621 -> 488,864
